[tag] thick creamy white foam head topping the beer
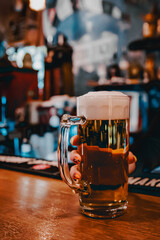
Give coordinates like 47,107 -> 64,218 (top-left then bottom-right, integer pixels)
77,91 -> 129,120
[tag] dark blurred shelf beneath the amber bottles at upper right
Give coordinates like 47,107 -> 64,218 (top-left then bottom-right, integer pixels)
128,37 -> 160,51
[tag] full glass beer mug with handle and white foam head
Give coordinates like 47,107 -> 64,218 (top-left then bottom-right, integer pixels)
58,91 -> 129,218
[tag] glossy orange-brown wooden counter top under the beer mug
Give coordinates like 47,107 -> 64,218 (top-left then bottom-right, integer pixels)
0,169 -> 160,240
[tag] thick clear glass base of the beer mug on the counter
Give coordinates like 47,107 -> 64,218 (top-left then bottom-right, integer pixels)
80,202 -> 128,218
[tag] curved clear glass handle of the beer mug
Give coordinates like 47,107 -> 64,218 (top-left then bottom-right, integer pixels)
58,114 -> 90,195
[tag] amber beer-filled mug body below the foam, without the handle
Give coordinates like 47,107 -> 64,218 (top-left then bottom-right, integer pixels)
78,119 -> 129,217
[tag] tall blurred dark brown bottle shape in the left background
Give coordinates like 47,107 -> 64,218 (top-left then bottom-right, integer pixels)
45,33 -> 74,99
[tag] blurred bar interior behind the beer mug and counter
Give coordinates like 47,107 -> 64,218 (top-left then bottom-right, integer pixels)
0,0 -> 160,175
